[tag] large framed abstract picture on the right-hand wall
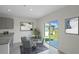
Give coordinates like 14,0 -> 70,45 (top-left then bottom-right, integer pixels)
65,17 -> 79,34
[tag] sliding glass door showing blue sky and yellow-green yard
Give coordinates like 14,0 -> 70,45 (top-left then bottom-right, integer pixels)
44,20 -> 59,48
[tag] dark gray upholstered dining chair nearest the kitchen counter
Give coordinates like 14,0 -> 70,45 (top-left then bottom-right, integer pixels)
21,37 -> 32,53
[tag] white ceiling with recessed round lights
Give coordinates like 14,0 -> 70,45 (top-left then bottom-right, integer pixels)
0,5 -> 65,18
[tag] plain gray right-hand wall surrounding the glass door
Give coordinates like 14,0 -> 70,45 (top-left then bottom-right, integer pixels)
38,6 -> 79,53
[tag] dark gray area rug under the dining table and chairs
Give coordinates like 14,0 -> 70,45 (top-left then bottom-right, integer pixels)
20,44 -> 48,54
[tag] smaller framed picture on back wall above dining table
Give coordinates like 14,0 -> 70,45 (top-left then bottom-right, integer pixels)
20,22 -> 32,31
